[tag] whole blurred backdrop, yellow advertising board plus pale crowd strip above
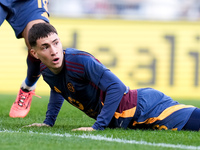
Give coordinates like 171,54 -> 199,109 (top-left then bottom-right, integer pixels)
0,0 -> 200,99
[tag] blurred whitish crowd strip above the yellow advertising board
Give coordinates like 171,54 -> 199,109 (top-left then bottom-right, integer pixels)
49,0 -> 200,21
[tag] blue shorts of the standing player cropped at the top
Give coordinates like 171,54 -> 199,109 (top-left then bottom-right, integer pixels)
0,0 -> 49,38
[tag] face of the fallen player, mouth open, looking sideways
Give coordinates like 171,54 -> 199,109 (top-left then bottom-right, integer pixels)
31,33 -> 63,74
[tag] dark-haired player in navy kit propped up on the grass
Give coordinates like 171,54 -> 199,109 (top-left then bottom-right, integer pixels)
25,23 -> 200,131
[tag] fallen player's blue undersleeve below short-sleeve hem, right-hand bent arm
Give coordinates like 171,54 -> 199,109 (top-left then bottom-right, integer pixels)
92,70 -> 126,130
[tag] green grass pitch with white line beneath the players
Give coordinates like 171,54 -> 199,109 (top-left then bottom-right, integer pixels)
0,95 -> 200,150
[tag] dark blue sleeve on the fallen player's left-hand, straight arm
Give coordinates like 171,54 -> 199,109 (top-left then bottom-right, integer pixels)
44,89 -> 64,126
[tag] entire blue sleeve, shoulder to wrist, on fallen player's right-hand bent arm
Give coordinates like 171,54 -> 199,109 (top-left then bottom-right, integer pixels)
81,54 -> 126,130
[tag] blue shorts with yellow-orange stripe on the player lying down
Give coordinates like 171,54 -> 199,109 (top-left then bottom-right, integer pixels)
132,88 -> 196,130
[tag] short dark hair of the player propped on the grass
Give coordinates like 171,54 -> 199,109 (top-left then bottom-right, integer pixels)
28,23 -> 58,47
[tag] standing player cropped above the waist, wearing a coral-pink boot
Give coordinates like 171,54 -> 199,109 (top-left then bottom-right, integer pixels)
0,0 -> 49,118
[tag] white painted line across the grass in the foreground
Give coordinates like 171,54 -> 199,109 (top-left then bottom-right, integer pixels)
0,130 -> 200,150
